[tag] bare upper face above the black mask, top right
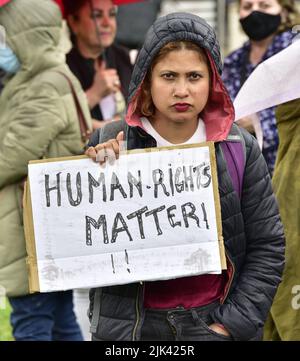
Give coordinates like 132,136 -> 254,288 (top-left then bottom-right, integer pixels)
240,0 -> 282,19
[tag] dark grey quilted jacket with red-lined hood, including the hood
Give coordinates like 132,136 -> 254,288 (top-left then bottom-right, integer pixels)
90,13 -> 284,340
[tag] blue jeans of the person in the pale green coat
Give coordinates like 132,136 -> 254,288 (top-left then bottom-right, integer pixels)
9,291 -> 83,341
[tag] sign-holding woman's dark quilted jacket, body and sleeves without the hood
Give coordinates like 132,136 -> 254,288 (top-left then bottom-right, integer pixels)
89,124 -> 284,340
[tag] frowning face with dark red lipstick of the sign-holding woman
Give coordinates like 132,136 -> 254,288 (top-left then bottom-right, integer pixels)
151,49 -> 210,123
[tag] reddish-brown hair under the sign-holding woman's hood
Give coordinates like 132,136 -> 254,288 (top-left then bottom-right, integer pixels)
139,41 -> 209,117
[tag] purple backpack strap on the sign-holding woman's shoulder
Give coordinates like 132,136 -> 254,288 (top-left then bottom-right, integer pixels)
221,124 -> 246,199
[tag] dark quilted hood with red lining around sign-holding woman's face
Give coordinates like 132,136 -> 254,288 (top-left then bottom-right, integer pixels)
126,13 -> 234,141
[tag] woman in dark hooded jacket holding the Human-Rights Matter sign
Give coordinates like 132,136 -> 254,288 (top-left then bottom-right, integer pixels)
86,13 -> 284,341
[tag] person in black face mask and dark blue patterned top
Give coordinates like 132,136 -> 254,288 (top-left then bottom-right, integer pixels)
222,0 -> 299,175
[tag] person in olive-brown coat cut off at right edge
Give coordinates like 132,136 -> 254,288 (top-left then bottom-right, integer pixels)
264,99 -> 300,341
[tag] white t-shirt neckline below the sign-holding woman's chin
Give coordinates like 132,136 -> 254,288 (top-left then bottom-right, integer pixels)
141,117 -> 206,147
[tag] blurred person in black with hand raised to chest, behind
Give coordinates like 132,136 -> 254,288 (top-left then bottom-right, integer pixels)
64,0 -> 132,128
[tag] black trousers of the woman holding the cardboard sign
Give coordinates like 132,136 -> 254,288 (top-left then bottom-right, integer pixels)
141,302 -> 233,341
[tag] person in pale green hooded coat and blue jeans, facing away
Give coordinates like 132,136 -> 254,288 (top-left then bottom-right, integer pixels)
0,0 -> 92,341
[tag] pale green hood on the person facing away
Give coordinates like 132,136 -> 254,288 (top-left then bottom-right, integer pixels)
0,0 -> 63,73
